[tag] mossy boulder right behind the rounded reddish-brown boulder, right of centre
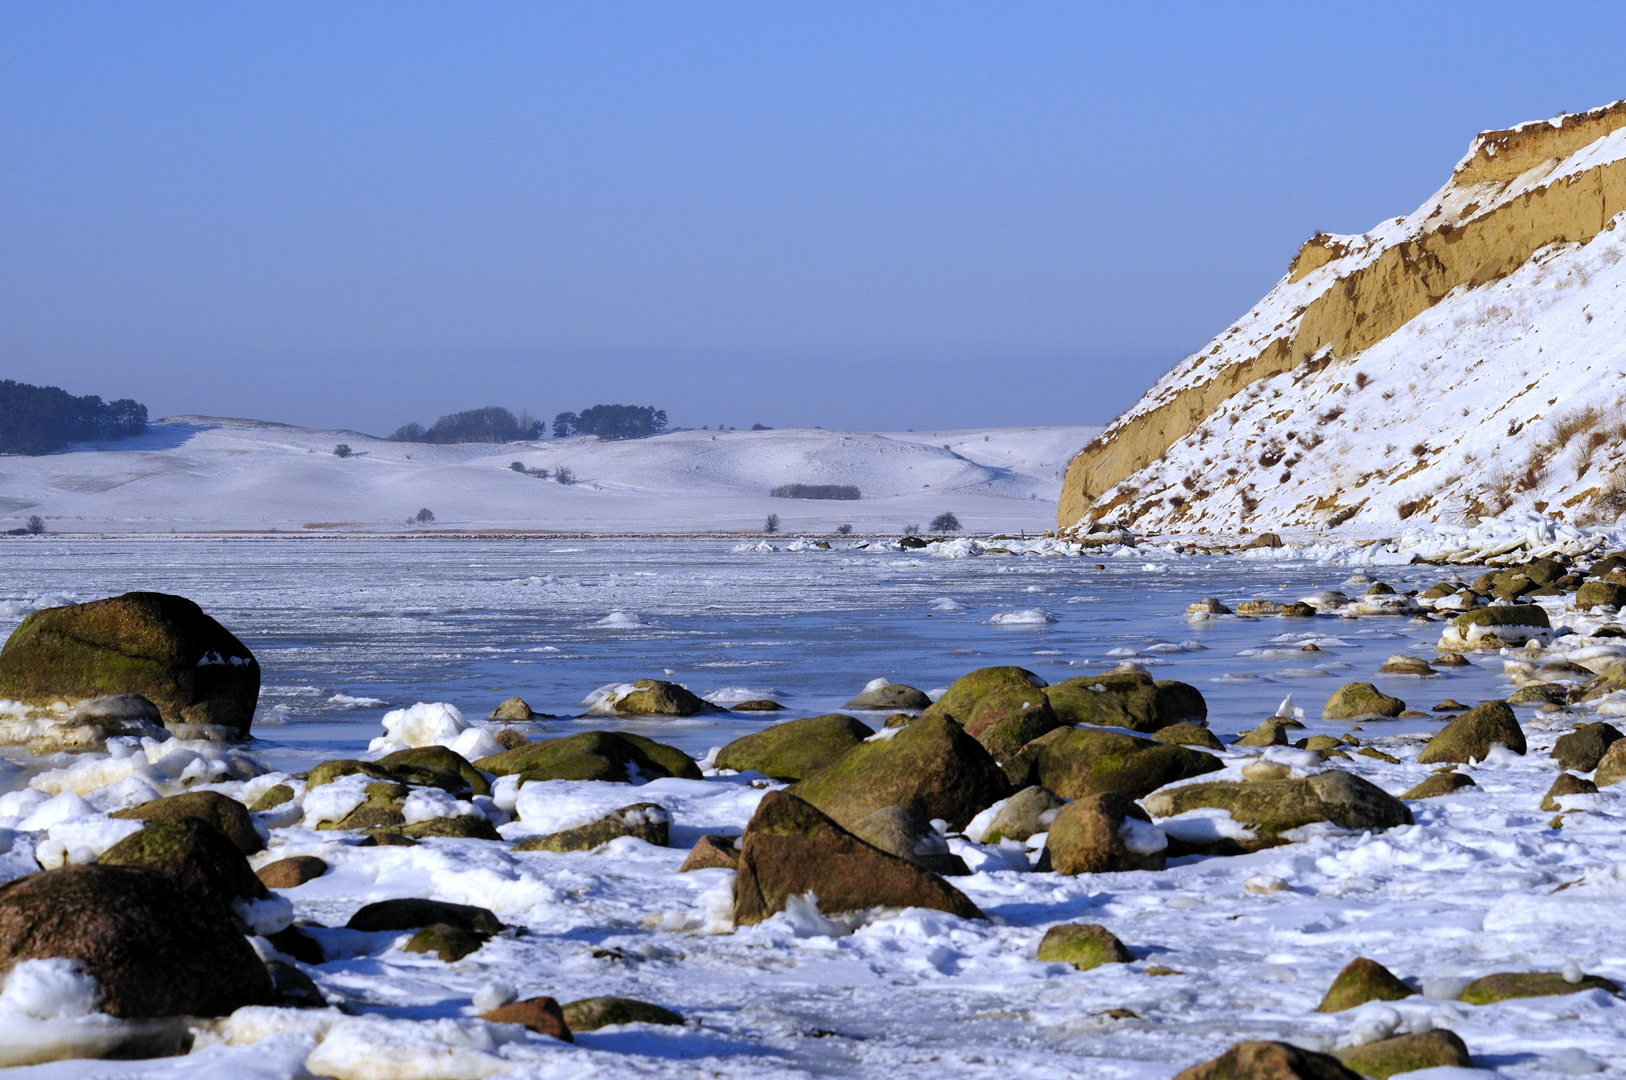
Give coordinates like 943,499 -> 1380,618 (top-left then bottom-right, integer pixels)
1031,727 -> 1224,799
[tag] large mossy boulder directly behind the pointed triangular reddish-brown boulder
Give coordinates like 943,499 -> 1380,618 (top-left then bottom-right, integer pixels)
787,712 -> 1010,828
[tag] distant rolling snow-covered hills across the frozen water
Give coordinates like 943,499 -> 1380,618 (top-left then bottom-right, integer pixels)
0,416 -> 1099,533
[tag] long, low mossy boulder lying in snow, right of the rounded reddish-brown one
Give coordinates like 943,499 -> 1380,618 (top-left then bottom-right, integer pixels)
1145,771 -> 1413,836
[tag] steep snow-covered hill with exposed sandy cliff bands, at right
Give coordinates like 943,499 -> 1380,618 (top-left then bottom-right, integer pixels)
1059,102 -> 1626,533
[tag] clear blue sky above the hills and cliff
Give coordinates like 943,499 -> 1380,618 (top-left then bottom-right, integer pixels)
0,0 -> 1626,433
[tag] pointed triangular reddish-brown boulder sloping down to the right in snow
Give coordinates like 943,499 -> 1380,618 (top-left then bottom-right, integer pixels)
734,790 -> 984,930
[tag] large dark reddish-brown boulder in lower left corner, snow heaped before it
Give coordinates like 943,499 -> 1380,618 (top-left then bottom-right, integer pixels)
0,849 -> 272,1018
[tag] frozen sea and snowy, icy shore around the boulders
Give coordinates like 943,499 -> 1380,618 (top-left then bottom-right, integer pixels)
0,537 -> 1626,1080
